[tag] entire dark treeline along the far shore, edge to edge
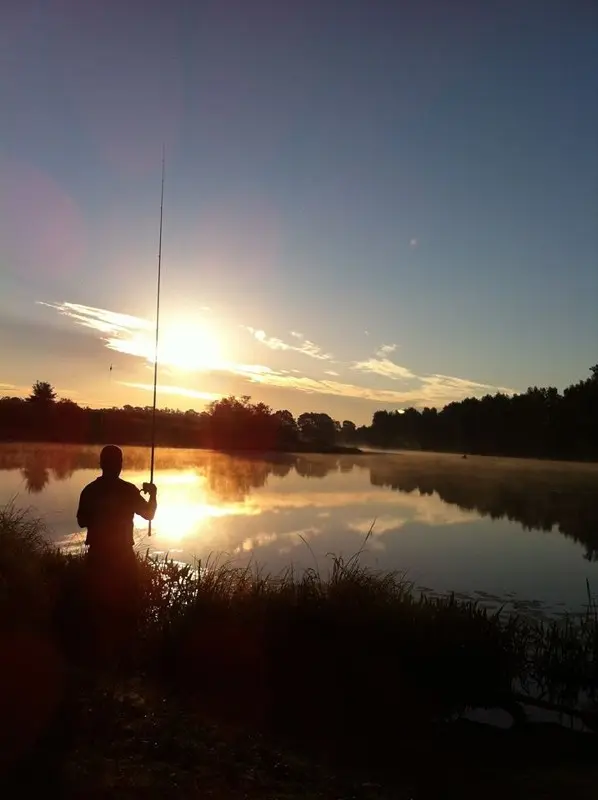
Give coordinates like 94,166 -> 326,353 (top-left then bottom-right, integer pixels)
0,365 -> 598,460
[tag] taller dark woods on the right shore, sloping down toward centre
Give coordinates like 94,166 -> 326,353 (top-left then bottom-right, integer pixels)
366,365 -> 598,460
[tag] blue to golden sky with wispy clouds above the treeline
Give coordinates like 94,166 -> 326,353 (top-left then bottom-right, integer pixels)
0,0 -> 598,423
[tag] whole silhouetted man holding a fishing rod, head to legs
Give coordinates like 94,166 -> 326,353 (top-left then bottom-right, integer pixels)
77,445 -> 157,658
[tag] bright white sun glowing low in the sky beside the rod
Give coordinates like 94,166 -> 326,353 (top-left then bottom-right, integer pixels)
158,322 -> 223,372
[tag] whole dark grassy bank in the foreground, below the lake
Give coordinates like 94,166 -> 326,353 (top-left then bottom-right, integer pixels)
0,506 -> 598,798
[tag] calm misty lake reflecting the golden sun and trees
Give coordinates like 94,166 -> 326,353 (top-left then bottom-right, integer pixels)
0,445 -> 598,613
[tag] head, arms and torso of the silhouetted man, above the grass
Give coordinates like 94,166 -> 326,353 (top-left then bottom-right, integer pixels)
77,444 -> 157,559
